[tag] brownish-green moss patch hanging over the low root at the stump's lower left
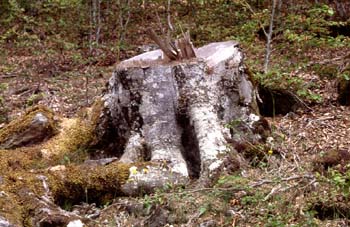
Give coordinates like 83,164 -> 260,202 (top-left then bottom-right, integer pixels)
49,163 -> 130,207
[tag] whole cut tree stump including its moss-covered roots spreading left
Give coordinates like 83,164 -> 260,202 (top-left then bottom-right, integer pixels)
0,41 -> 268,226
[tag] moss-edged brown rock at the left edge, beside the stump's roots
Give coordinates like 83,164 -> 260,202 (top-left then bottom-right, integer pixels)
0,106 -> 57,149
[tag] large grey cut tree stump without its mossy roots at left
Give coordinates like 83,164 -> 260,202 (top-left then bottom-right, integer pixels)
95,41 -> 259,194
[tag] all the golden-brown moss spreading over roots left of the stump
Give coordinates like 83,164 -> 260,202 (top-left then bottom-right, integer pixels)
0,100 -> 121,223
